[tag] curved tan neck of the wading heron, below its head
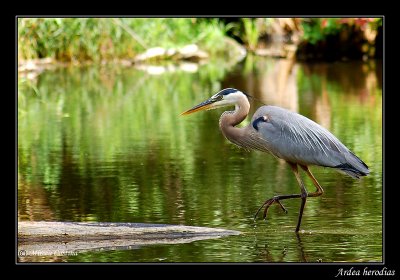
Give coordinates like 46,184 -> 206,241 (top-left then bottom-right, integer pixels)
219,96 -> 250,144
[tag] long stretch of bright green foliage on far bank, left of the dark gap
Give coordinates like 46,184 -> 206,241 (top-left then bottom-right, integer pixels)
18,18 -> 228,61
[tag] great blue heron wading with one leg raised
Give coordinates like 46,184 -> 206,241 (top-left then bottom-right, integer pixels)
182,88 -> 369,232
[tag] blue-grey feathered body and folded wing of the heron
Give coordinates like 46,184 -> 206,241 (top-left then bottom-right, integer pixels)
244,106 -> 369,177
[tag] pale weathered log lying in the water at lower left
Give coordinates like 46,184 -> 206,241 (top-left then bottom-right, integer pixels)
18,222 -> 240,258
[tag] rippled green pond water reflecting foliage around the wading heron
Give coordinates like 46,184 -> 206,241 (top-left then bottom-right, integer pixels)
18,57 -> 383,263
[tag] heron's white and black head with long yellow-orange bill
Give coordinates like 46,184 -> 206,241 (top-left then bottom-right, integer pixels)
181,88 -> 247,115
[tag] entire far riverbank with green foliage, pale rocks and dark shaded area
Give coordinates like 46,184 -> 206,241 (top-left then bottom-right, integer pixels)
18,18 -> 383,79
